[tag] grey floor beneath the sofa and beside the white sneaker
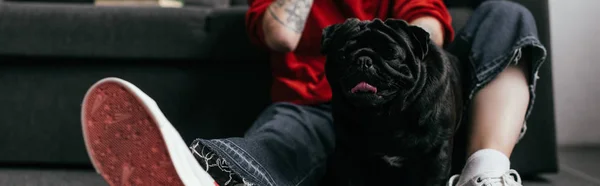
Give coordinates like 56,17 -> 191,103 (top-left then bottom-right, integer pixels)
0,147 -> 600,186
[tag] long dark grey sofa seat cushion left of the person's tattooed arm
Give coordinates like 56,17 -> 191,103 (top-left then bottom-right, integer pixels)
0,2 -> 210,58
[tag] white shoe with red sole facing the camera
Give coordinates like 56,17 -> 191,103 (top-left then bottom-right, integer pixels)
81,78 -> 218,186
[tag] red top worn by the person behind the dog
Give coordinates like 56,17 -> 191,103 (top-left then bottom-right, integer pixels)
246,0 -> 454,104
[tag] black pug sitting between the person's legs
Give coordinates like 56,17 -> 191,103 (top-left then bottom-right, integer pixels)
322,18 -> 463,186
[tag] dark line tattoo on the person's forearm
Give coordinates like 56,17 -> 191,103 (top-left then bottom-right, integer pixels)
269,0 -> 313,33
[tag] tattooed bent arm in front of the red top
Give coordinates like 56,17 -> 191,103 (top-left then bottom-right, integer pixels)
262,0 -> 313,52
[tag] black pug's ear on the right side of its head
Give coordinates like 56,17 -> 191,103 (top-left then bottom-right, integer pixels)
385,19 -> 430,59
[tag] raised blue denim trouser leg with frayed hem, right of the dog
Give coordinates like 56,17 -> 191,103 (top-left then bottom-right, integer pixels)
447,0 -> 546,138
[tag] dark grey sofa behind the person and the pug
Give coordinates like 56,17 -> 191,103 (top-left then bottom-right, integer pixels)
0,0 -> 557,174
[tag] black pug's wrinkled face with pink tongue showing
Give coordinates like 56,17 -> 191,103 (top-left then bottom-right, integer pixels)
321,18 -> 430,107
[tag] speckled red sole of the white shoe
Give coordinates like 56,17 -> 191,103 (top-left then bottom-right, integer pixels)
83,82 -> 183,186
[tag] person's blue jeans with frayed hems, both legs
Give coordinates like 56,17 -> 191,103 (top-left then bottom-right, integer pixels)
193,1 -> 546,186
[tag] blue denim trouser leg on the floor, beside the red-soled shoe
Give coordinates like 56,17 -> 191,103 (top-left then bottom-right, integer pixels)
192,103 -> 335,186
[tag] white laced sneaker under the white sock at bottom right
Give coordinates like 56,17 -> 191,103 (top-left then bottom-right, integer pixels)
447,169 -> 523,186
